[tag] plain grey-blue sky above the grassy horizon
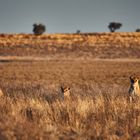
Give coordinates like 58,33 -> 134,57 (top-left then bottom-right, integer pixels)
0,0 -> 140,33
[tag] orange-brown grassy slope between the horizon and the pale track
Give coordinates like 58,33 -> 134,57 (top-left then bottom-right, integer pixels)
0,32 -> 140,58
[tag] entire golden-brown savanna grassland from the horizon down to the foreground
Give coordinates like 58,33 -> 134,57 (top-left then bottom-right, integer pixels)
0,33 -> 140,140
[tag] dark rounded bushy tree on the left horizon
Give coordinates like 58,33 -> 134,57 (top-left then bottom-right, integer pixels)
33,23 -> 46,35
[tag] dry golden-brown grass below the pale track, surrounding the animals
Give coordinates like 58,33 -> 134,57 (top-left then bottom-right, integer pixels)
0,60 -> 140,140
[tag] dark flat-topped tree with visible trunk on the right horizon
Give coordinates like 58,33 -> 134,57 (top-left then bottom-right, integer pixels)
108,22 -> 122,32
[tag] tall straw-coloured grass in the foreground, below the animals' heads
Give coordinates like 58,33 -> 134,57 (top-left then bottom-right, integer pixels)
0,86 -> 140,140
